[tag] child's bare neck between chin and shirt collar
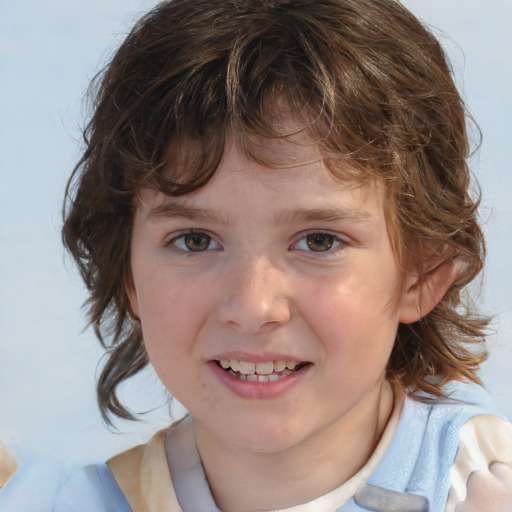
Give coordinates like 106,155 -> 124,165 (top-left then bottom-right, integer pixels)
193,381 -> 393,512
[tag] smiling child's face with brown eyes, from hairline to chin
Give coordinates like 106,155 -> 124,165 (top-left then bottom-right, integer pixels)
131,136 -> 412,451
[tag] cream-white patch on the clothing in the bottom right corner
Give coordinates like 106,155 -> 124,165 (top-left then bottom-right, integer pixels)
446,414 -> 512,512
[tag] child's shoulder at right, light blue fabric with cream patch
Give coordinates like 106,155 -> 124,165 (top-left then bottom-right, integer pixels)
410,390 -> 512,512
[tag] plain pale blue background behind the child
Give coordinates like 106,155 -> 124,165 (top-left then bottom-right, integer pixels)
0,0 -> 512,462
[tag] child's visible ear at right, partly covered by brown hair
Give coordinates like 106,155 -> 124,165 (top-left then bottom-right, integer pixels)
398,259 -> 461,324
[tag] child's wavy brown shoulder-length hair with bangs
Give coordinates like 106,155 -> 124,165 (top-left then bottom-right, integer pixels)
63,0 -> 486,421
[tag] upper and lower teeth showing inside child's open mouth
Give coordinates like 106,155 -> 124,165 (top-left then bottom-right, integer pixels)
216,359 -> 310,382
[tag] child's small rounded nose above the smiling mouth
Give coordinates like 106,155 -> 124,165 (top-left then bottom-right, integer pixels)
218,257 -> 291,333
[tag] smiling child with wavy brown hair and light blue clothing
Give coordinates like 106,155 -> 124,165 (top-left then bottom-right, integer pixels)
5,0 -> 512,512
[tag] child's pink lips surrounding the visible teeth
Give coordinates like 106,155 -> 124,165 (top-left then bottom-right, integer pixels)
207,354 -> 312,399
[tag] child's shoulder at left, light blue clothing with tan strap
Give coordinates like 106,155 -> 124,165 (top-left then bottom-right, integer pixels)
0,430 -> 181,512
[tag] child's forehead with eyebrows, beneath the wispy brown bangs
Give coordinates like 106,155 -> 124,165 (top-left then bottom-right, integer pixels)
134,139 -> 384,231
